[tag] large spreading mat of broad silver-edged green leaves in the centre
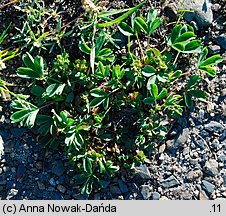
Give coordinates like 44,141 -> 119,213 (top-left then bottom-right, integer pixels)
11,0 -> 221,194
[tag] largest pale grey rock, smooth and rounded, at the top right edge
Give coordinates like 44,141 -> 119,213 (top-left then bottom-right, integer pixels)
181,0 -> 213,28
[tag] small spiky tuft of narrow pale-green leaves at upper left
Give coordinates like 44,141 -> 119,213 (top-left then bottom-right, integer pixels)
12,0 -> 72,53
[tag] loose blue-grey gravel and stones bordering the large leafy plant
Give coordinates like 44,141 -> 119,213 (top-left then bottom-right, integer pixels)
0,0 -> 226,200
